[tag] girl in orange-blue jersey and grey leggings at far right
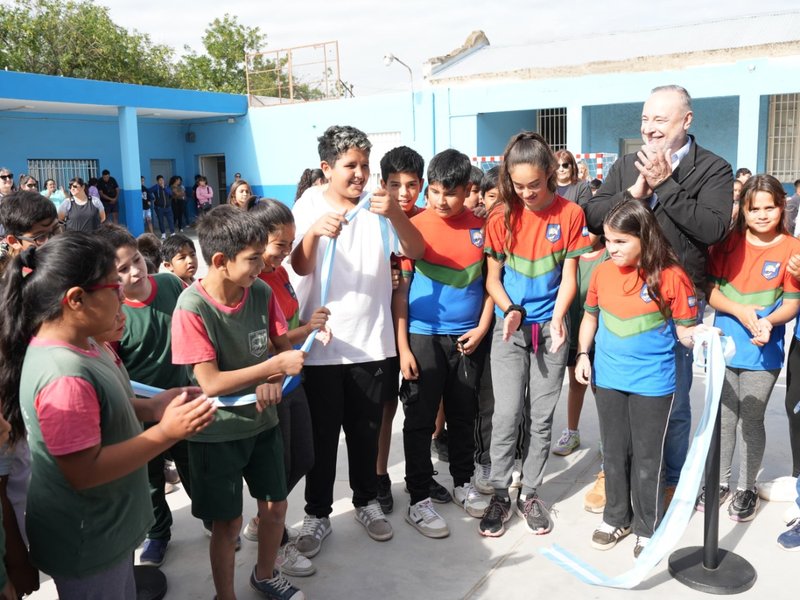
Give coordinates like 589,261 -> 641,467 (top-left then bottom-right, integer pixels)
698,175 -> 800,521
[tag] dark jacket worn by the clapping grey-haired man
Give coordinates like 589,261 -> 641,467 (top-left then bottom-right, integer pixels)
584,136 -> 733,295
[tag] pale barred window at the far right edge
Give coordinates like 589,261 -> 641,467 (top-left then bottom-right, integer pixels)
767,94 -> 800,181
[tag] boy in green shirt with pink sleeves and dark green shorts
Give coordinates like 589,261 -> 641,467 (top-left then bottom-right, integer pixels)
172,205 -> 305,600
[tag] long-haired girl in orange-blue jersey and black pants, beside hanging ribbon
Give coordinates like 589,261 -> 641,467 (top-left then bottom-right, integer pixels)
575,198 -> 697,557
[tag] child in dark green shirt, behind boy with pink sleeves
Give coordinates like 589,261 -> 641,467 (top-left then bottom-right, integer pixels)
96,223 -> 191,566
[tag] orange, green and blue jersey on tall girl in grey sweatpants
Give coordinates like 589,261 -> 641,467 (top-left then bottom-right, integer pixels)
484,195 -> 591,324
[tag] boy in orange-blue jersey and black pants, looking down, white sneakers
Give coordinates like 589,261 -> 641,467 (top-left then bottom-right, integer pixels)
397,150 -> 494,538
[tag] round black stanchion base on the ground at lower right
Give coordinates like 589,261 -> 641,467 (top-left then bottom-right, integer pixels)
669,546 -> 756,595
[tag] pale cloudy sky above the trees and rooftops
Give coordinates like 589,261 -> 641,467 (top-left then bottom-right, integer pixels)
98,0 -> 797,96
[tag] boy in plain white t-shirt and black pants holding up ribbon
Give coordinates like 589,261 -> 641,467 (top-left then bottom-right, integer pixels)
292,126 -> 424,557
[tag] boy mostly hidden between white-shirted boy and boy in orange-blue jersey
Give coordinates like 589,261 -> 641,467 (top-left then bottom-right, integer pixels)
376,146 -> 425,514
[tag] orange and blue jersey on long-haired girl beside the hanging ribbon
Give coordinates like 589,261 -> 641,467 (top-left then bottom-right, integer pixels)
584,261 -> 697,396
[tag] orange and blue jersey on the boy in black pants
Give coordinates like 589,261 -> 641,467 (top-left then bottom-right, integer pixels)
401,210 -> 484,335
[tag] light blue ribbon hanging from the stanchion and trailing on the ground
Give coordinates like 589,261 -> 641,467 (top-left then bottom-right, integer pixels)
541,330 -> 735,589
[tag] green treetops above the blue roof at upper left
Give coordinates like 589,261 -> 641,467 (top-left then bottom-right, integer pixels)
0,0 -> 346,100
